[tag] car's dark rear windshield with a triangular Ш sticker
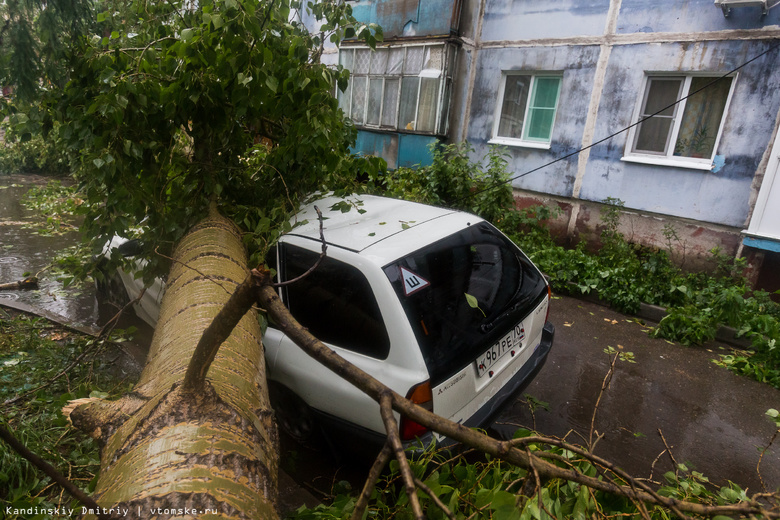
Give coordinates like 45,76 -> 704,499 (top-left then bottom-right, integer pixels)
384,222 -> 547,385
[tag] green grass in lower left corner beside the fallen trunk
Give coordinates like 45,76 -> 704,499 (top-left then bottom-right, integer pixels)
0,309 -> 130,520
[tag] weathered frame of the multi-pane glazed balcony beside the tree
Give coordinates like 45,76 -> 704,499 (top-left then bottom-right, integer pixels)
336,41 -> 457,136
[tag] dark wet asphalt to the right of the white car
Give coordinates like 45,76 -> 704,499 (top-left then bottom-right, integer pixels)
492,296 -> 780,493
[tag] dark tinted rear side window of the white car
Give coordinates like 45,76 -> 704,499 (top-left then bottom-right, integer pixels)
280,244 -> 390,359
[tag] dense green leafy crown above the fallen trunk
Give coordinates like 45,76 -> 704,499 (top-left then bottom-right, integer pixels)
5,0 -> 383,276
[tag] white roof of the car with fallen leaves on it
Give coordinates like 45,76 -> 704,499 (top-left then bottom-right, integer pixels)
287,195 -> 482,264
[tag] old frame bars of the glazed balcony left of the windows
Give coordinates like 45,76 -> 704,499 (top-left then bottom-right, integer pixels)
337,42 -> 457,136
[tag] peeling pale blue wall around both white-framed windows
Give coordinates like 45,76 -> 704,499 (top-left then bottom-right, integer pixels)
466,0 -> 780,227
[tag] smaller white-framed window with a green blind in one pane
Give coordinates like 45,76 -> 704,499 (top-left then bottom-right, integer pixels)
490,72 -> 561,148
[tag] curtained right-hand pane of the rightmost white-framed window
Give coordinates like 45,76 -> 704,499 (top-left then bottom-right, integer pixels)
674,77 -> 731,158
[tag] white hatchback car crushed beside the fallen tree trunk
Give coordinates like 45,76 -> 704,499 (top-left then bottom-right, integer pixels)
102,196 -> 554,443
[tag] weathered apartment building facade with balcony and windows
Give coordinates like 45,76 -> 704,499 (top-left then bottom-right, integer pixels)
304,0 -> 780,288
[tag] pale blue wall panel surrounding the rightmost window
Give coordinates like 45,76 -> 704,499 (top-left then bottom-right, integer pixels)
580,39 -> 780,226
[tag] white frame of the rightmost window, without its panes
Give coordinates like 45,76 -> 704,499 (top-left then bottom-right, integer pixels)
621,72 -> 737,170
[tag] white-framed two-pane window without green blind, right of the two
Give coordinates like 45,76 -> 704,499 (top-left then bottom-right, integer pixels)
624,75 -> 734,169
